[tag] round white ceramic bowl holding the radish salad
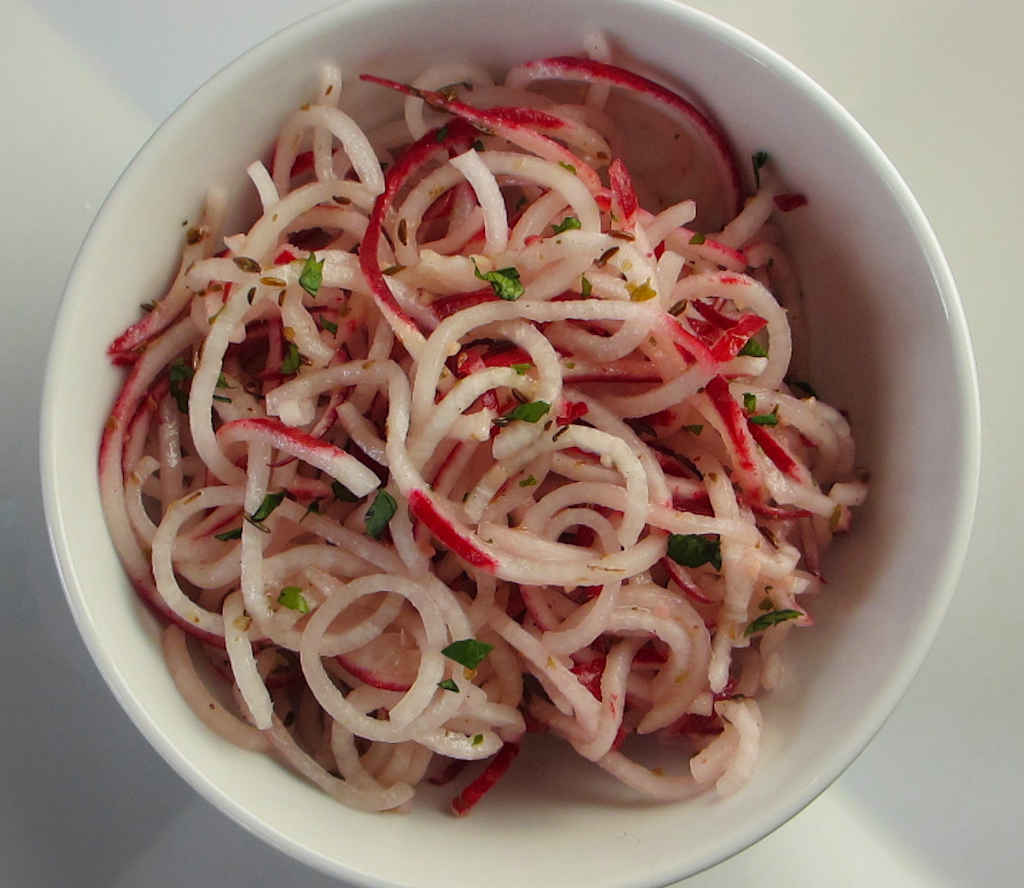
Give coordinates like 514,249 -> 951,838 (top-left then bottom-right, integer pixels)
41,0 -> 979,888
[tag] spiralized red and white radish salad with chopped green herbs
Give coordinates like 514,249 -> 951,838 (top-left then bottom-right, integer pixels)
99,35 -> 866,814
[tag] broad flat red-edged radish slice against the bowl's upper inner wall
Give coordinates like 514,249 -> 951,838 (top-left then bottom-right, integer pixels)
506,56 -> 742,231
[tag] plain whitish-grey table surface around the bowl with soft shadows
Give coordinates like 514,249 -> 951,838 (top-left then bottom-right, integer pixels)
6,0 -> 1024,888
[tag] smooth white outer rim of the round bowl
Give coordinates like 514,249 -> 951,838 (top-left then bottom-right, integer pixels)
39,0 -> 981,888
